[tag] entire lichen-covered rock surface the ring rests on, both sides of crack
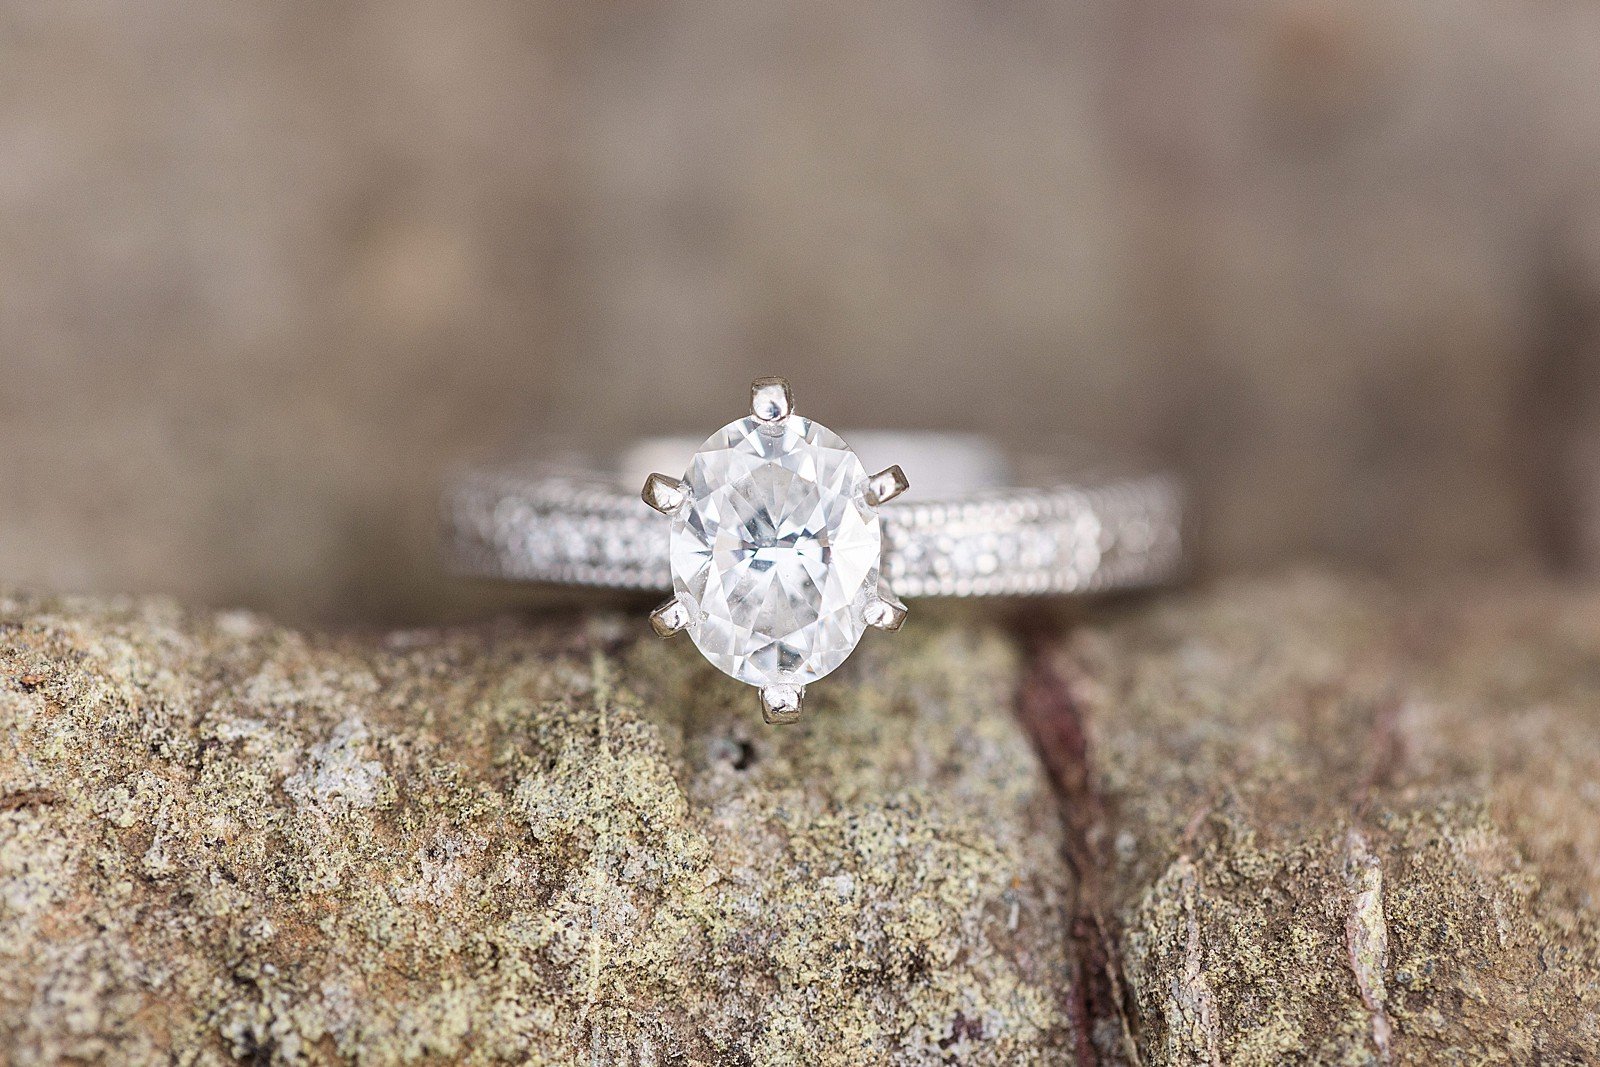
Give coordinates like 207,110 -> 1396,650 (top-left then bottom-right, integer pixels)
0,577 -> 1600,1067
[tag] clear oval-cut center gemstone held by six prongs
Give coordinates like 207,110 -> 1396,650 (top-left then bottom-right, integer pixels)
670,414 -> 883,686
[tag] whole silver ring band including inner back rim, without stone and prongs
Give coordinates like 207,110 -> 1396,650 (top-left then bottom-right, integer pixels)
445,432 -> 1182,598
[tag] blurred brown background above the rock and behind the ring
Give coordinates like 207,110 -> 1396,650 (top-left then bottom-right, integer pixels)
0,0 -> 1600,621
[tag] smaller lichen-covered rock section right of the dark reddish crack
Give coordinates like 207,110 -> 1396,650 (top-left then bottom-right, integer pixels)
1035,579 -> 1600,1065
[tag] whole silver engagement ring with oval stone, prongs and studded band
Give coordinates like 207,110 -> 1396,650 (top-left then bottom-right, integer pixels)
446,378 -> 1182,723
